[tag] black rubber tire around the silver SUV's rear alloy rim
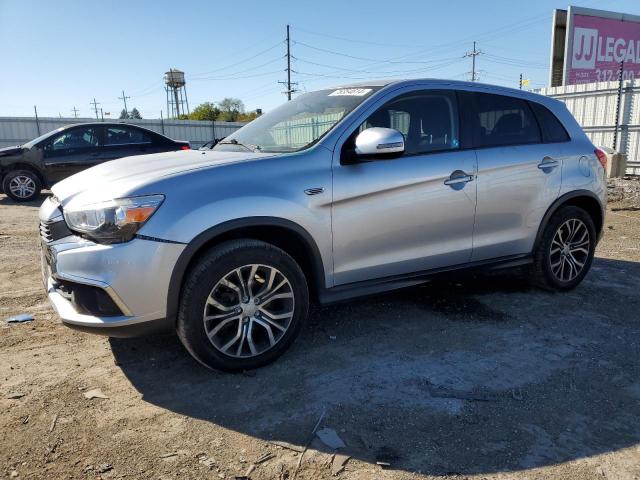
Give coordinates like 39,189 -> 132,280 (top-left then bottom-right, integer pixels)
531,205 -> 597,291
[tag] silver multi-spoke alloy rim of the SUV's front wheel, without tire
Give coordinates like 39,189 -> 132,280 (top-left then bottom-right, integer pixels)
203,264 -> 295,358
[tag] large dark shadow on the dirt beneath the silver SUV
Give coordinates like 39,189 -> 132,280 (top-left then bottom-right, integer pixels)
111,259 -> 640,474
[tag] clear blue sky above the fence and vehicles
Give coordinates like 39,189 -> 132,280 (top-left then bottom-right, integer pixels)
0,0 -> 640,118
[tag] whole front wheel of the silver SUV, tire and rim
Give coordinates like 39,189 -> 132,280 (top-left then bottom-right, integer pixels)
177,239 -> 309,371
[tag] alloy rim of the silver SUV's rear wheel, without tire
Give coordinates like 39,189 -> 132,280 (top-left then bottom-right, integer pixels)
549,218 -> 591,282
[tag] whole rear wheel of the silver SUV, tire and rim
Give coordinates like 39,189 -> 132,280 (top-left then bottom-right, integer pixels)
532,206 -> 596,291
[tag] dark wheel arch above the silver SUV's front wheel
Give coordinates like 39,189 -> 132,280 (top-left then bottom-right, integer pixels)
167,217 -> 325,320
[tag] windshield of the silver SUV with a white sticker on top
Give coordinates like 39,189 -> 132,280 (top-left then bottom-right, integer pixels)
213,87 -> 380,153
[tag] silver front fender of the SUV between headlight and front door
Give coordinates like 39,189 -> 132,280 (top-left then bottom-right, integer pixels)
140,145 -> 332,287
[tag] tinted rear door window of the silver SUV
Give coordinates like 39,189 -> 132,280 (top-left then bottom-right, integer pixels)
474,93 -> 542,147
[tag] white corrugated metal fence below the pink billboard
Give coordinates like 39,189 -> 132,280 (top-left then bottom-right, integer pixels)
536,80 -> 640,175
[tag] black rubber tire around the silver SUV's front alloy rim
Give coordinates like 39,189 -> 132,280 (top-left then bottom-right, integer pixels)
176,239 -> 309,372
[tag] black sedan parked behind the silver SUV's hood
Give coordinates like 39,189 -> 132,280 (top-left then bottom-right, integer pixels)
0,122 -> 189,202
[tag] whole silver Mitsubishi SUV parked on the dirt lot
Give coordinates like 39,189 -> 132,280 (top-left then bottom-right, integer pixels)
40,80 -> 606,370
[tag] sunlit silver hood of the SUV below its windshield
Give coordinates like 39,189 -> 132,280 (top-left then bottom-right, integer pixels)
51,150 -> 274,206
